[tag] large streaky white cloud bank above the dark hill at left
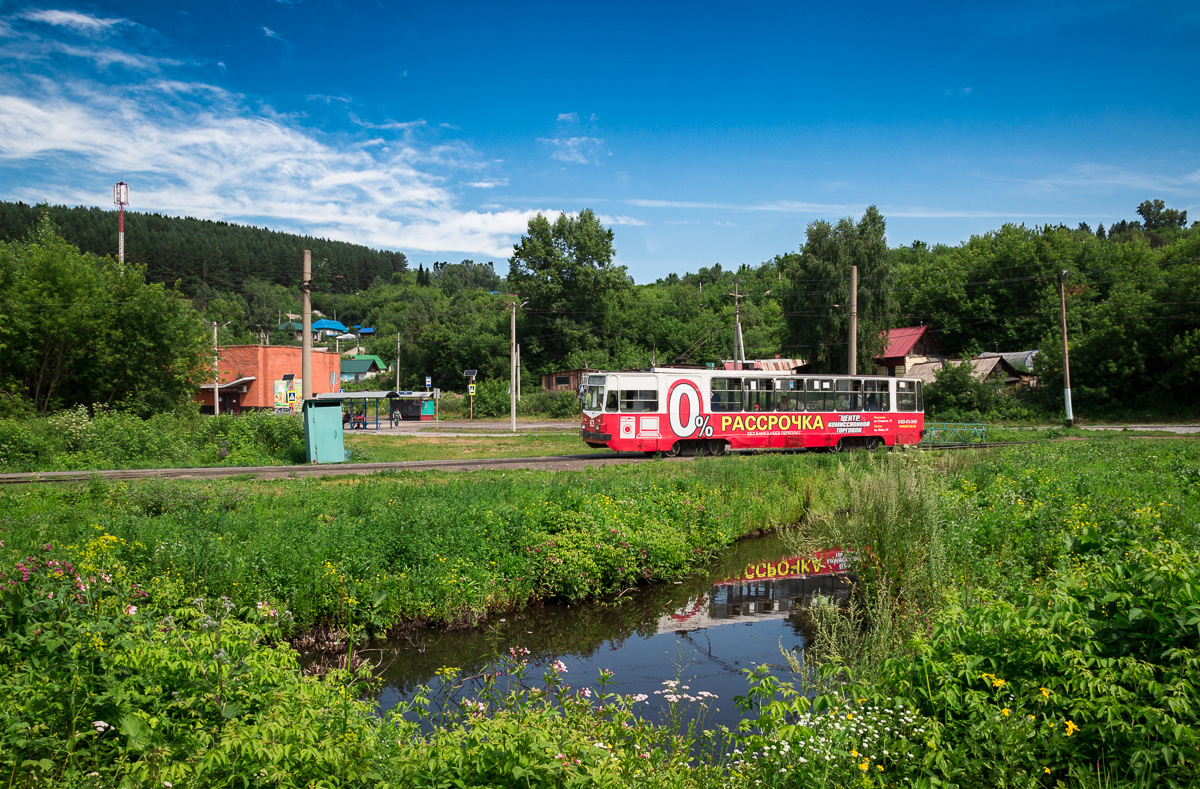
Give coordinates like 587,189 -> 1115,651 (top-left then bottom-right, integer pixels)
0,80 -> 535,257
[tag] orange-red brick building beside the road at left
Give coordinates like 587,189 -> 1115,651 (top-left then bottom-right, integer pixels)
196,345 -> 341,414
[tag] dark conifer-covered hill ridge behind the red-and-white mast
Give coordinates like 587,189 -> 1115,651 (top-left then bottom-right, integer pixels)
0,201 -> 408,296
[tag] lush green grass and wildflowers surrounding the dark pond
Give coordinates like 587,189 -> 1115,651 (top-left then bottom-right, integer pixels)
0,440 -> 1200,787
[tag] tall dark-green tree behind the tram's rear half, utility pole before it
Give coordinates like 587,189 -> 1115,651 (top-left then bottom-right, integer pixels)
775,205 -> 894,373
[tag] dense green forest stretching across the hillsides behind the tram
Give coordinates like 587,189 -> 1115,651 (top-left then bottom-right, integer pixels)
0,200 -> 1200,416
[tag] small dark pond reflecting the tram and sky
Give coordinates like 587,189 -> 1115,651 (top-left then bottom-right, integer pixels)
371,527 -> 852,727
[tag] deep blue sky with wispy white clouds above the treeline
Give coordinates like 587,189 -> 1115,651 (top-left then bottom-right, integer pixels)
0,0 -> 1200,282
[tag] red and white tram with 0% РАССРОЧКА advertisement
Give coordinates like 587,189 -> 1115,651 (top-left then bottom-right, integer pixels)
580,367 -> 925,457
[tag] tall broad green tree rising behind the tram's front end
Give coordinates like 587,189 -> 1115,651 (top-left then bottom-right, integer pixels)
509,209 -> 631,372
